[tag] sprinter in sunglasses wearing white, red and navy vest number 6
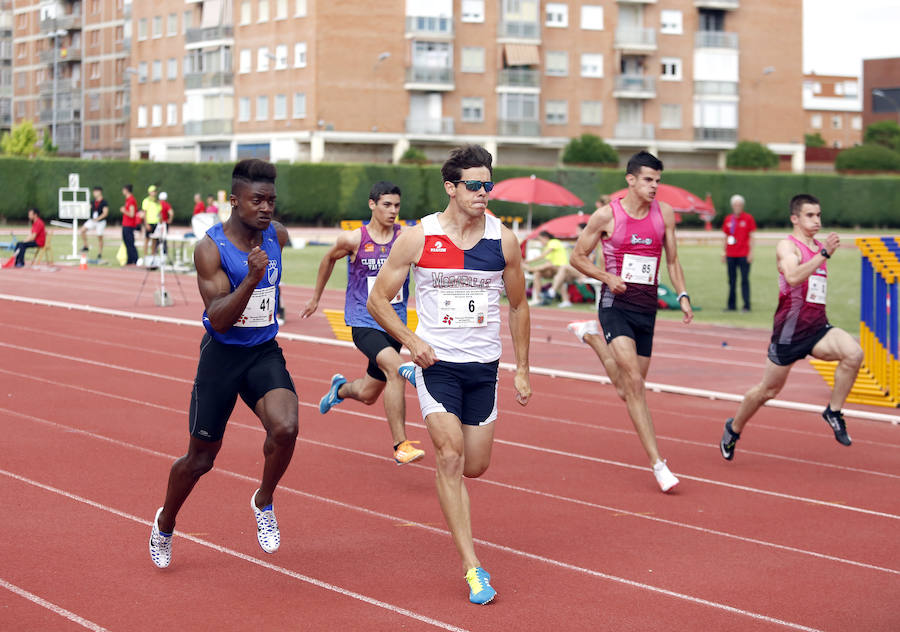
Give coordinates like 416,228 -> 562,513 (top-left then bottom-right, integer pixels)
368,145 -> 531,604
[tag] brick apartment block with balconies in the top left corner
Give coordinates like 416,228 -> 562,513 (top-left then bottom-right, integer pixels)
7,0 -> 131,157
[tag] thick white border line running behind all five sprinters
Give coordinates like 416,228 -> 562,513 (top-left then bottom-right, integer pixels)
0,294 -> 900,425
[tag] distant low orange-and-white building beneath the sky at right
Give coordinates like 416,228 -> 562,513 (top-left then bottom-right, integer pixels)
803,74 -> 863,149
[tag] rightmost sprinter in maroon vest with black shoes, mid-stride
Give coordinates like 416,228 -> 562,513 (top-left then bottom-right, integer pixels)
719,193 -> 863,461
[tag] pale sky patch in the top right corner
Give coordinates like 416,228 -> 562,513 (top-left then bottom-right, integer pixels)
803,0 -> 900,77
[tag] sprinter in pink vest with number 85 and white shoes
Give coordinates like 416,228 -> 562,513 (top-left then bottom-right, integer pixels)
569,151 -> 694,492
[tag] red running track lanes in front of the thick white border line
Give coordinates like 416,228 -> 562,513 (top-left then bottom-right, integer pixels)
0,268 -> 900,630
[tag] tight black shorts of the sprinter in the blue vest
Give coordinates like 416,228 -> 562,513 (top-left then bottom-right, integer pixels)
189,333 -> 297,441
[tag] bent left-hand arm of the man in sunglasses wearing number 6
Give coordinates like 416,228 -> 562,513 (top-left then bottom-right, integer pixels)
366,224 -> 437,368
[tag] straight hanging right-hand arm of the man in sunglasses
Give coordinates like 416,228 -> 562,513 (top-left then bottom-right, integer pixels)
500,226 -> 531,406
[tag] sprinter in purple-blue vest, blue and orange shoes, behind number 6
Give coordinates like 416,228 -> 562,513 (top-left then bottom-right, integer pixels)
300,181 -> 425,465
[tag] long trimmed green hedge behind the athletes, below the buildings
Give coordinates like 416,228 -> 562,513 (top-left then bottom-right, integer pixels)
0,157 -> 900,227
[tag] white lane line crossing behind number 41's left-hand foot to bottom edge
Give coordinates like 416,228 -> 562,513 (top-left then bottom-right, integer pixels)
0,469 -> 466,632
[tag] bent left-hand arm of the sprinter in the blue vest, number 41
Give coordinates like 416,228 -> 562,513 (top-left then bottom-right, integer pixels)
194,235 -> 269,333
